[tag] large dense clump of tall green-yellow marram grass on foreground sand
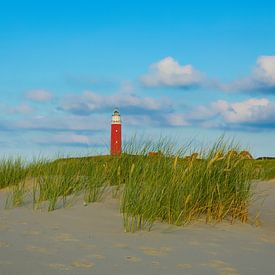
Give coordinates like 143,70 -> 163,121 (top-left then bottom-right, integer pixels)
121,139 -> 257,231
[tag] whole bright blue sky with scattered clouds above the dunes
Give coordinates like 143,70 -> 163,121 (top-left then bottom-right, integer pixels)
0,0 -> 275,156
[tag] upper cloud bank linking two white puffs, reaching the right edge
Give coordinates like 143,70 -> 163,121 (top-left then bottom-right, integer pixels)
140,55 -> 275,93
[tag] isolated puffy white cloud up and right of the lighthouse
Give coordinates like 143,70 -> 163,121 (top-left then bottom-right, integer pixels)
140,57 -> 204,88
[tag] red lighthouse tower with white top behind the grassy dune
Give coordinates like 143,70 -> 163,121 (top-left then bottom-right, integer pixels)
111,109 -> 121,155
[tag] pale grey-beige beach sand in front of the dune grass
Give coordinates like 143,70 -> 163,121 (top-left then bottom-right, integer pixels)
0,181 -> 275,275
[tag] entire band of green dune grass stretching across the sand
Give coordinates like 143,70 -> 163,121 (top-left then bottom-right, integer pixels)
0,139 -> 275,232
